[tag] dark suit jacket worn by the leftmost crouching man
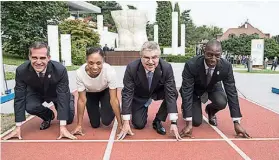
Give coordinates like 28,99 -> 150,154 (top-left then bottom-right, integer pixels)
14,61 -> 70,122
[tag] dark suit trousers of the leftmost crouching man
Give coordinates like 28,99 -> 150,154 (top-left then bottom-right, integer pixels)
26,90 -> 75,124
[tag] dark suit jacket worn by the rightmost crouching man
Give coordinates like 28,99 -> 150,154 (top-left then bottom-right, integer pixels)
180,55 -> 242,118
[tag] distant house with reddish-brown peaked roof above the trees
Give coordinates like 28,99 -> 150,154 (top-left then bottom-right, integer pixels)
217,21 -> 270,41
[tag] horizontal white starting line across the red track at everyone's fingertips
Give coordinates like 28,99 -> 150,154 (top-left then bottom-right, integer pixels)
1,138 -> 279,143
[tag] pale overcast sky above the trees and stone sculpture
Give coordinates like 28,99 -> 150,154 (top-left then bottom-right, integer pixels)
118,0 -> 279,36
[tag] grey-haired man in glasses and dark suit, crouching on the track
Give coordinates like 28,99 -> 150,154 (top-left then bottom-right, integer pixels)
118,42 -> 180,139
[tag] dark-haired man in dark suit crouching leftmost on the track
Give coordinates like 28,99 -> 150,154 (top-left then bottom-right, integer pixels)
5,42 -> 76,139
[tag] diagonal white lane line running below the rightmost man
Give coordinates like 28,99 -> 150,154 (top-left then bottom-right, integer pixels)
203,116 -> 251,160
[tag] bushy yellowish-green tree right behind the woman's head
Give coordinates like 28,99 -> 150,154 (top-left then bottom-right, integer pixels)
59,20 -> 100,65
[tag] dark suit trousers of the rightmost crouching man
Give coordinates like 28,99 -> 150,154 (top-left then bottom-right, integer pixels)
192,91 -> 227,127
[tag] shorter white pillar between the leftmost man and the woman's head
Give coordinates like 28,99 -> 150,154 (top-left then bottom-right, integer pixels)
60,34 -> 72,66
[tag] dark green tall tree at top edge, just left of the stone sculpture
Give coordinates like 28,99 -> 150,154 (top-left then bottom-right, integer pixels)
87,1 -> 122,32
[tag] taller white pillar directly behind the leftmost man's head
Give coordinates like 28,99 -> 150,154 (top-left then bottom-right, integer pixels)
47,25 -> 59,62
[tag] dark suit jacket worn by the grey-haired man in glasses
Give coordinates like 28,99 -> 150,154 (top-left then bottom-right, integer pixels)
122,59 -> 178,115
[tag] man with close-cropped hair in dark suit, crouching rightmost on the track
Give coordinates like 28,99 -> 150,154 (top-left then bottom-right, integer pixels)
180,40 -> 253,137
